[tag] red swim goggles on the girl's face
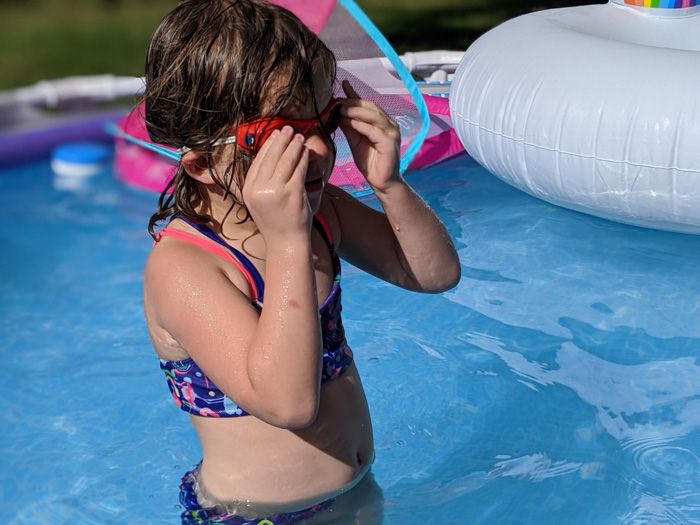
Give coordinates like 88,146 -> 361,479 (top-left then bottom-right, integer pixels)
180,98 -> 344,154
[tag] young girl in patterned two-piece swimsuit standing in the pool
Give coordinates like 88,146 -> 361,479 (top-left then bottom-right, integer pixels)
144,0 -> 460,525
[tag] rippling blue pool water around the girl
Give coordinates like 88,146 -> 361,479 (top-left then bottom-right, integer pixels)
0,157 -> 700,525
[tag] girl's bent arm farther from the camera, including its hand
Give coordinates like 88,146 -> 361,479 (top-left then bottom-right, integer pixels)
327,82 -> 460,292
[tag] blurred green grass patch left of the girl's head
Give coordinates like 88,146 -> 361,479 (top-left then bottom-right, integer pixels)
0,0 -> 176,88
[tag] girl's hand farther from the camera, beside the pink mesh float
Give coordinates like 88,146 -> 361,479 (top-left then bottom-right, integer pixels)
340,80 -> 401,191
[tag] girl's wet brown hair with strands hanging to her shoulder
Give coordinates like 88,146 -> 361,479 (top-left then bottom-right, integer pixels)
144,0 -> 336,235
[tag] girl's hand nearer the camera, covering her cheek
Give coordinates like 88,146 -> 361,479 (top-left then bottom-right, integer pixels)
243,126 -> 311,241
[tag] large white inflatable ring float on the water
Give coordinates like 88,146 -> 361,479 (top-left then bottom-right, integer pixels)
450,0 -> 700,234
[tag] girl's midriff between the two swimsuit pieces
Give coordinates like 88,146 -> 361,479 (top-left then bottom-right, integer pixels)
190,364 -> 374,504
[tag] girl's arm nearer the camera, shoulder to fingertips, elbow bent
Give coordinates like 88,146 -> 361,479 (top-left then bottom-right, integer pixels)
146,128 -> 322,428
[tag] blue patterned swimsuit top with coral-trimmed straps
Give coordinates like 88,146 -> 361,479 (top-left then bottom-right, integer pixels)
156,214 -> 353,417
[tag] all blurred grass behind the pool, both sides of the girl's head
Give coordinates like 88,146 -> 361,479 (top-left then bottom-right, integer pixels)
0,0 -> 590,89
